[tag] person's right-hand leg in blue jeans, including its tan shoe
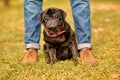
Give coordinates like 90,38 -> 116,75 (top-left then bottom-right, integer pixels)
71,0 -> 96,64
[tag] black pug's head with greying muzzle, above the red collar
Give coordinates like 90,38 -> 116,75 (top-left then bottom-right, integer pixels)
39,8 -> 66,30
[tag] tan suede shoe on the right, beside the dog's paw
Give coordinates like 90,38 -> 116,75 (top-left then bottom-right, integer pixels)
80,48 -> 97,66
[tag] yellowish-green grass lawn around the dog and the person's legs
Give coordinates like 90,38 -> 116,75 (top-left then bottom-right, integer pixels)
0,0 -> 120,80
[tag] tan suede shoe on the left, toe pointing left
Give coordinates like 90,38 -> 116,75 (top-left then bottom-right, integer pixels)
22,48 -> 38,64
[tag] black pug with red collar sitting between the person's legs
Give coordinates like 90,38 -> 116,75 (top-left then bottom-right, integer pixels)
39,8 -> 78,65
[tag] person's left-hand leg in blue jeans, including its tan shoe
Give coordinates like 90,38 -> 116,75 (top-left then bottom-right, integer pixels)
22,0 -> 43,63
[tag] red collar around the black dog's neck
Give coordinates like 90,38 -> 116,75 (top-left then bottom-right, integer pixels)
44,23 -> 65,38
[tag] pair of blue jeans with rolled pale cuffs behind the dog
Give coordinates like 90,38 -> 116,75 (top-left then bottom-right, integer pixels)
24,0 -> 91,50
